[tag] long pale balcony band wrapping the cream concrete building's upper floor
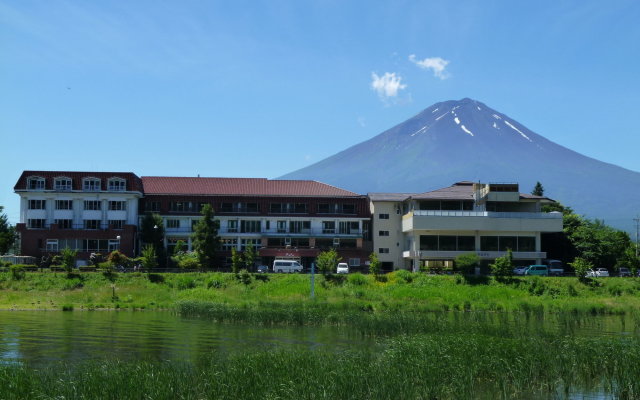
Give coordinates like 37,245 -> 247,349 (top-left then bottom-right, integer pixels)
402,210 -> 562,232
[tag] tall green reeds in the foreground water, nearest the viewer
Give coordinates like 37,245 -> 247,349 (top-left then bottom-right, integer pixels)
0,333 -> 640,399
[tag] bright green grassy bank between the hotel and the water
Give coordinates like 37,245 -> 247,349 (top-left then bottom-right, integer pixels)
0,271 -> 640,318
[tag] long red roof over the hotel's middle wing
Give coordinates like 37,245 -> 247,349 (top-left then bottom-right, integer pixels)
142,176 -> 360,197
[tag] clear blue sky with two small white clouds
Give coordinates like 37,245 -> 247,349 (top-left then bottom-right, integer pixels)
0,0 -> 640,223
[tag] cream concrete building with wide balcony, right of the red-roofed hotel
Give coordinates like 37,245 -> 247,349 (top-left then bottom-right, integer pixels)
369,182 -> 562,270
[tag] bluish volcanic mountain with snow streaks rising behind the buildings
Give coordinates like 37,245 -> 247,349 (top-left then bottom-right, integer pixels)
280,98 -> 640,232
